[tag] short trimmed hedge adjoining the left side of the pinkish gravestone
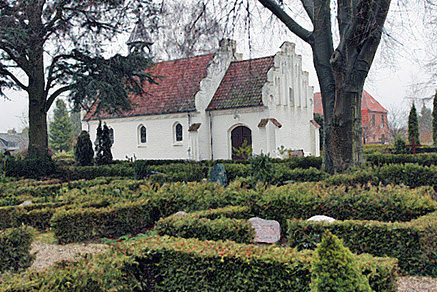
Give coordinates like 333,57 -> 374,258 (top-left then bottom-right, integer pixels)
155,207 -> 255,243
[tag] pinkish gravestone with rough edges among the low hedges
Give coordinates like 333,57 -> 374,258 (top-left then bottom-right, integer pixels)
249,217 -> 281,243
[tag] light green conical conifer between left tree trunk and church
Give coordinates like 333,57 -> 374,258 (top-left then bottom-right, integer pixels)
49,99 -> 73,151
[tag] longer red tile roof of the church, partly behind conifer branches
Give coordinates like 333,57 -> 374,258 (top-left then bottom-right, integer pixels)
84,54 -> 214,120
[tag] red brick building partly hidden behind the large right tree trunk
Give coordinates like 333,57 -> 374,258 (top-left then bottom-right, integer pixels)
314,90 -> 388,144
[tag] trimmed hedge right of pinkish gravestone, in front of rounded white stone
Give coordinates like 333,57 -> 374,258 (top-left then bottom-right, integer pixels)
286,212 -> 437,276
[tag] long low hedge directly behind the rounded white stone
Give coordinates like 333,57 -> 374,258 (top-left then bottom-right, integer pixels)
250,183 -> 437,226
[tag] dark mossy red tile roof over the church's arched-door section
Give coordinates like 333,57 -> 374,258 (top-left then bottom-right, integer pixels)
207,56 -> 274,110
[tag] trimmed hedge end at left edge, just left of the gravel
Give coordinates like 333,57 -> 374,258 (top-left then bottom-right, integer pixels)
0,226 -> 34,273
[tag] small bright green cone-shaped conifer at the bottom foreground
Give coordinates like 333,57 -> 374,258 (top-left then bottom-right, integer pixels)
311,231 -> 373,292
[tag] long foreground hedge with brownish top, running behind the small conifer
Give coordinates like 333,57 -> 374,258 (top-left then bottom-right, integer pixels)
117,236 -> 396,292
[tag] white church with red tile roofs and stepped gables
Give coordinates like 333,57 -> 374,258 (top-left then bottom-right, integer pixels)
82,22 -> 319,160
